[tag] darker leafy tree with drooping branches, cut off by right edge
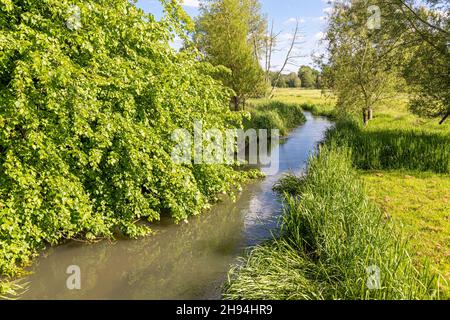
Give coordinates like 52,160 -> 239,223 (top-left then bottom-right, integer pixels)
381,0 -> 450,124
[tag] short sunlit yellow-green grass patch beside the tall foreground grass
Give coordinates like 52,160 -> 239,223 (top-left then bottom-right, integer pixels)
362,171 -> 450,297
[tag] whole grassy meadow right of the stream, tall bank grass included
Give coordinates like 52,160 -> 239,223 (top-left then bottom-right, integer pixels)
225,89 -> 450,299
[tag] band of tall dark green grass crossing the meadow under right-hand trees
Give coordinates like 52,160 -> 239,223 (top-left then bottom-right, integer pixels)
327,121 -> 450,173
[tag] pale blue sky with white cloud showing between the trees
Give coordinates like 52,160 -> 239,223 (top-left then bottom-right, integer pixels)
137,0 -> 330,73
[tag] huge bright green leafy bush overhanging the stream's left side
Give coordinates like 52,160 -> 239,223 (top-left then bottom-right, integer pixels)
0,0 -> 250,276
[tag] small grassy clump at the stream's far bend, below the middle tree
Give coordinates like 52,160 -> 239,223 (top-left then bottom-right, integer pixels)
244,101 -> 306,136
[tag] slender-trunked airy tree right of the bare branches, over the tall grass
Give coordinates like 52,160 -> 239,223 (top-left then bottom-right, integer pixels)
325,1 -> 402,124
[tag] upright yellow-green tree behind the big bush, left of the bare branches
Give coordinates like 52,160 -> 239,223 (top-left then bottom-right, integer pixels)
194,0 -> 266,110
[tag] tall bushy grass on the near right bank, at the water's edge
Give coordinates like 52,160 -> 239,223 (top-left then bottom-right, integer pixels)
224,148 -> 437,299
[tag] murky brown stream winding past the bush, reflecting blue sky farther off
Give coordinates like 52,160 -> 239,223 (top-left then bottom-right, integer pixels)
22,113 -> 331,299
